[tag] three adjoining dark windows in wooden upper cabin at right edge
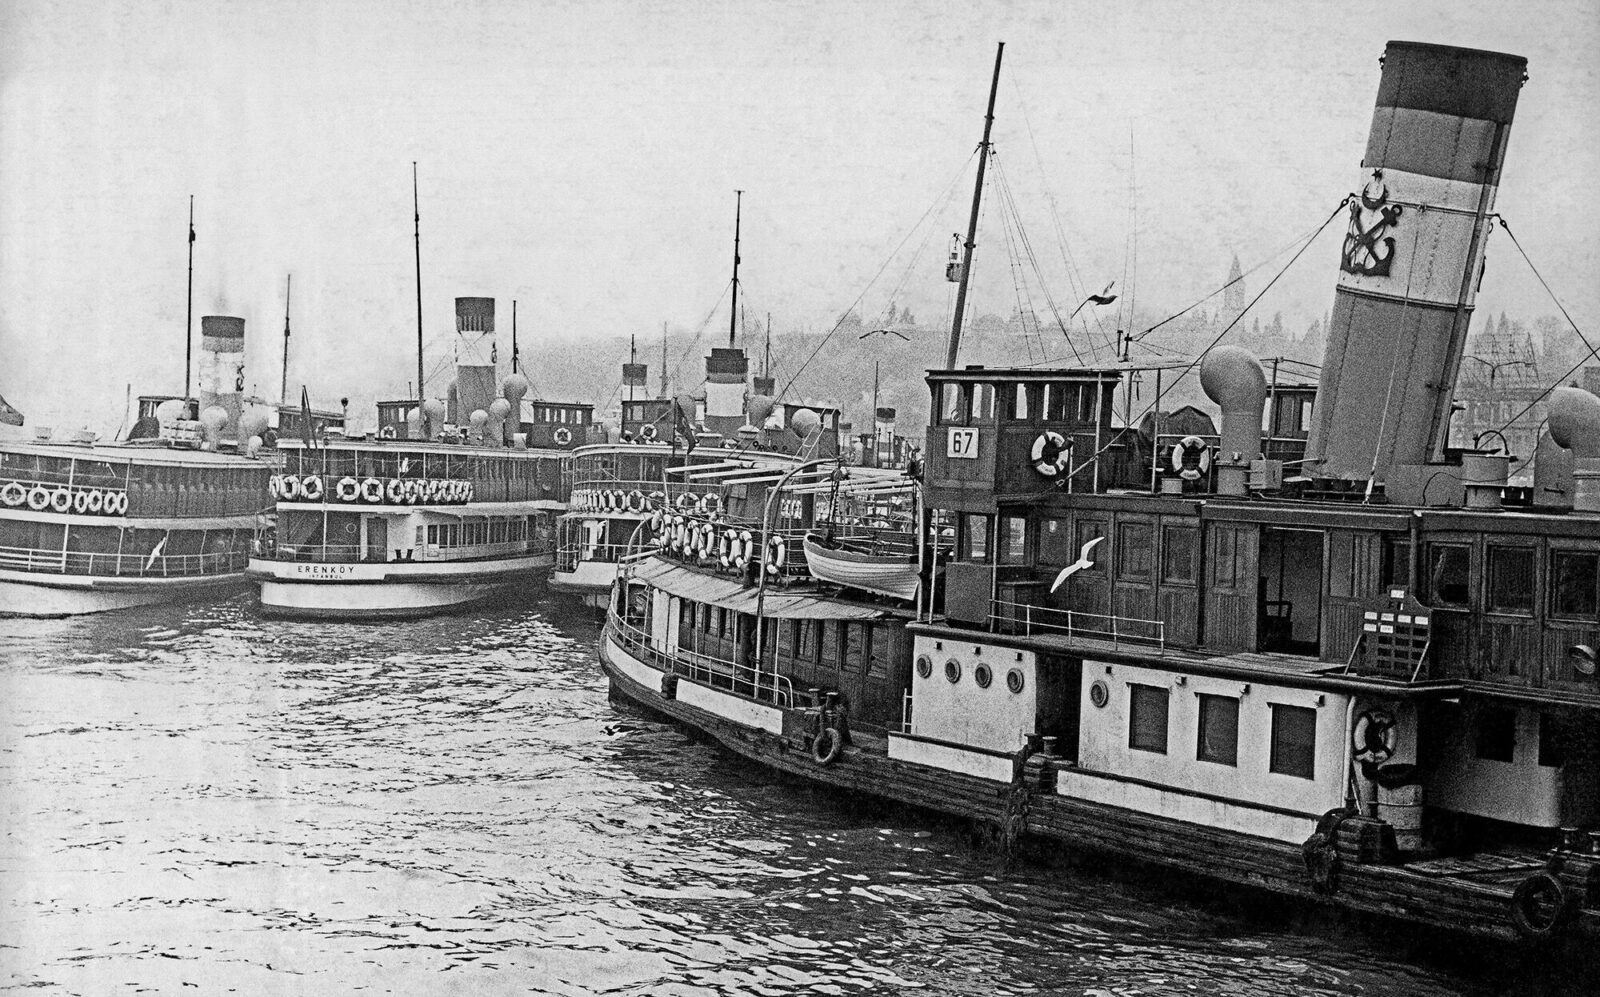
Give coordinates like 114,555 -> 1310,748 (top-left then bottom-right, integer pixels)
1422,543 -> 1600,621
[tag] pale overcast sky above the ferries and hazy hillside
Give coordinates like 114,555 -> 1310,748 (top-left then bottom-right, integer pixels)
0,0 -> 1600,430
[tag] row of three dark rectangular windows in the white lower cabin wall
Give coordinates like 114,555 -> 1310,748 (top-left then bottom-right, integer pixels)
1128,682 -> 1317,779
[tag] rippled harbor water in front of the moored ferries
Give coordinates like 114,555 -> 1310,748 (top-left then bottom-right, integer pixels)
0,595 -> 1561,997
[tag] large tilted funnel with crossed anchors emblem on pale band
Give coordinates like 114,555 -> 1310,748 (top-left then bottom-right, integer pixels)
1307,42 -> 1528,482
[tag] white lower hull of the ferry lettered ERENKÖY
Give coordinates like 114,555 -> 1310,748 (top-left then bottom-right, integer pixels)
248,554 -> 552,619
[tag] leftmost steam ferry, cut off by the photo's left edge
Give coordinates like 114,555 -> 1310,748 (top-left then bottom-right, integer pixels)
0,315 -> 270,616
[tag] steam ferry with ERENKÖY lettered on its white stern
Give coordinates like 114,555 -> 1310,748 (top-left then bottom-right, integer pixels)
248,298 -> 594,619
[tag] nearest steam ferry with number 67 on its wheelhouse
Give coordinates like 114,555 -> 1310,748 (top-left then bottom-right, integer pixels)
600,42 -> 1600,946
